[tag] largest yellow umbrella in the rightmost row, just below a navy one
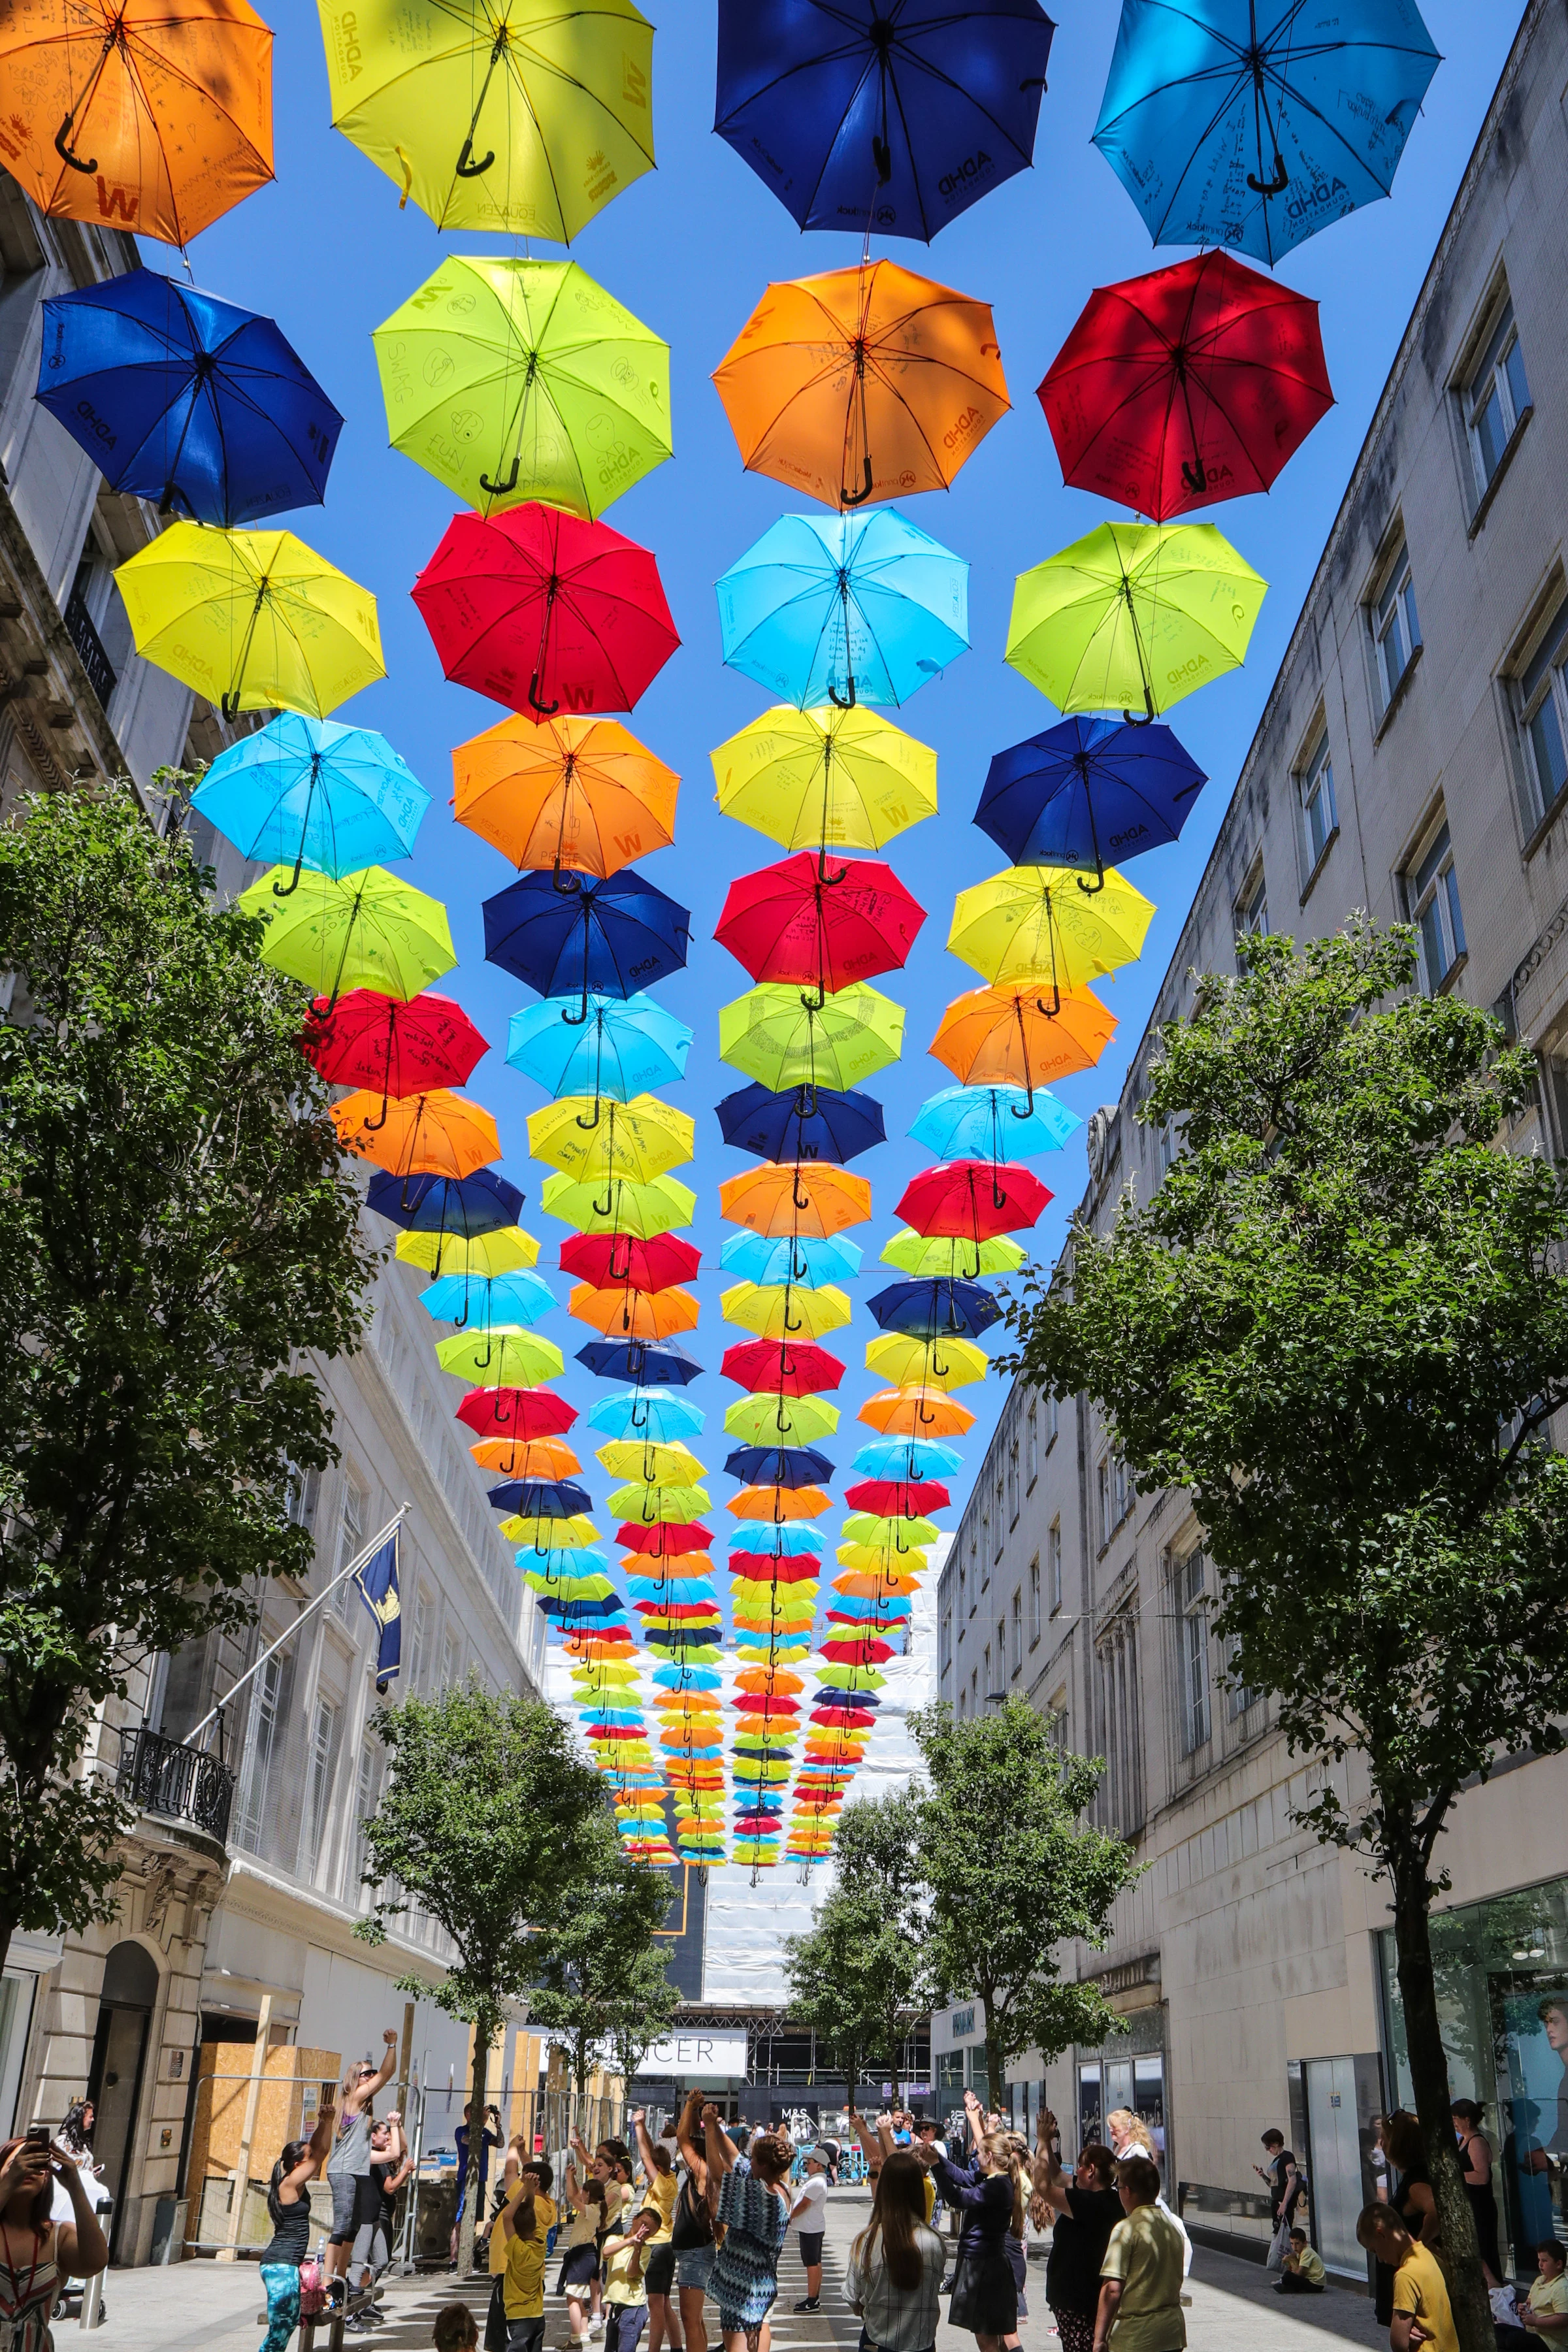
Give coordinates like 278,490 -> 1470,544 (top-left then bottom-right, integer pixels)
947,866 -> 1154,995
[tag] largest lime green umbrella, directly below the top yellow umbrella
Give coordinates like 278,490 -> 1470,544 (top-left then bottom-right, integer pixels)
372,254 -> 670,520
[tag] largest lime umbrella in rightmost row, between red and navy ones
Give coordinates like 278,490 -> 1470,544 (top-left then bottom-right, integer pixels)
1006,522 -> 1267,720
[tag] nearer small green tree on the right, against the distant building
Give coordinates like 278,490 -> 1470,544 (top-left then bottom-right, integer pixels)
910,1698 -> 1138,2108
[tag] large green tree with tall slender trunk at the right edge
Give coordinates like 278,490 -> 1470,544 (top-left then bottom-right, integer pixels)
1018,920 -> 1568,2352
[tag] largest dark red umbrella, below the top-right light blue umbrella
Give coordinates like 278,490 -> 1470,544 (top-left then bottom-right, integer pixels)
1039,250 -> 1333,522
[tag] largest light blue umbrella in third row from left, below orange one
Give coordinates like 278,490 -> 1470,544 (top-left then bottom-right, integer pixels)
717,506 -> 968,710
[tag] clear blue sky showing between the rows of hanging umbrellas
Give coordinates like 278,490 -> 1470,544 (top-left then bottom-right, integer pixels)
165,0 -> 1521,1637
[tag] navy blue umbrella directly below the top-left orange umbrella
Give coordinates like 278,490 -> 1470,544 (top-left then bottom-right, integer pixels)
38,270 -> 343,529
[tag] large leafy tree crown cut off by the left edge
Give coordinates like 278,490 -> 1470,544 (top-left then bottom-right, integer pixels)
0,779 -> 374,1985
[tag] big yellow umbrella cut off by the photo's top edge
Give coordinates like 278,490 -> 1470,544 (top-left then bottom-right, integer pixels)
322,0 -> 653,244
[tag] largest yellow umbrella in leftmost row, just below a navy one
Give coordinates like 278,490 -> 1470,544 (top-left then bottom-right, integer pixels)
115,522 -> 385,720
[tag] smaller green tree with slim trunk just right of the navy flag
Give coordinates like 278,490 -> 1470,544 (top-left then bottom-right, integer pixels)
355,1684 -> 604,2274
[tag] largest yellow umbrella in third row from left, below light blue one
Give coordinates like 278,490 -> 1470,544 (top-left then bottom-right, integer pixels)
712,703 -> 936,849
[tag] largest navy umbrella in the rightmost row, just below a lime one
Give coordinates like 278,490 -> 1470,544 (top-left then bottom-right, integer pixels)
975,717 -> 1208,889
